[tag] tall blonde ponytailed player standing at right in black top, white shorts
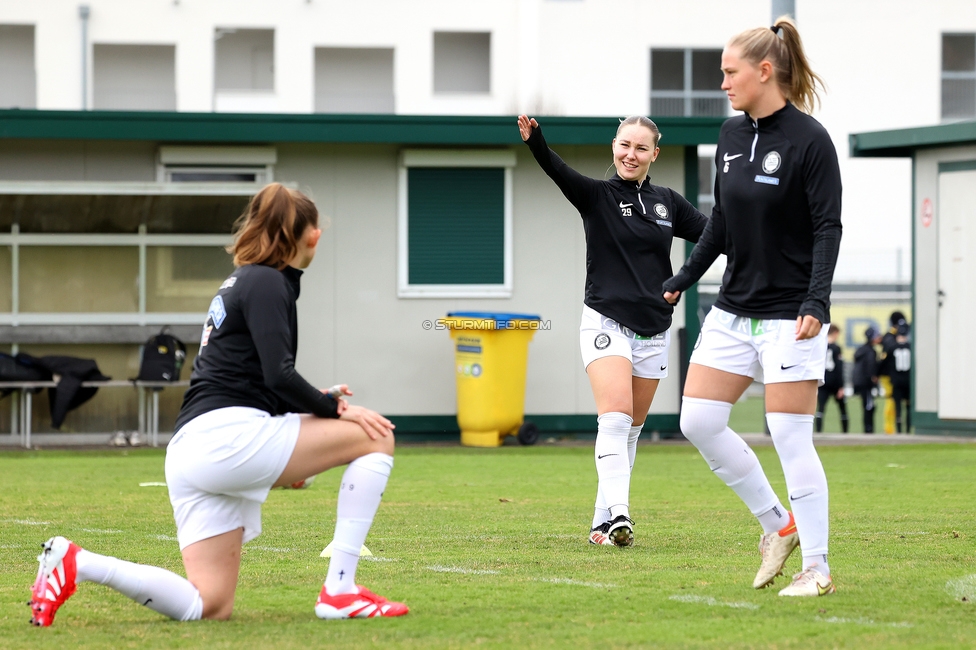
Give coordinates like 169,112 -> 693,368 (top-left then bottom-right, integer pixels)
664,17 -> 841,596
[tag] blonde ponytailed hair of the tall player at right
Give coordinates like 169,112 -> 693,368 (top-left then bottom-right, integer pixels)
729,16 -> 824,113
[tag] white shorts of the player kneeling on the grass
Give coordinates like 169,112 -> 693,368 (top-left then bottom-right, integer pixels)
166,406 -> 301,550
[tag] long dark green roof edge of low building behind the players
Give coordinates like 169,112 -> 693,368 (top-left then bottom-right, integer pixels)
0,109 -> 724,146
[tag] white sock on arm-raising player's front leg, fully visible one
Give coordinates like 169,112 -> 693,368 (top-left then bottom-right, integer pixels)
593,412 -> 634,519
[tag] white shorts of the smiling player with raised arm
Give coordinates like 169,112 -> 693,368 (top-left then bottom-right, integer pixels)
580,305 -> 671,379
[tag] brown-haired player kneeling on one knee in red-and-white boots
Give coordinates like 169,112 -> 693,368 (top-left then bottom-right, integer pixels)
30,183 -> 407,626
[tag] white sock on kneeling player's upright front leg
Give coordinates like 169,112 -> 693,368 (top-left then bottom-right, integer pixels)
325,452 -> 393,596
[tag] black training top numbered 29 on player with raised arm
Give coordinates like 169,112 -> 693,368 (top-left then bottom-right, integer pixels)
526,127 -> 707,336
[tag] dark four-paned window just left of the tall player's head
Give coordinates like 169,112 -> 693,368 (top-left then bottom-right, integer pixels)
651,49 -> 728,117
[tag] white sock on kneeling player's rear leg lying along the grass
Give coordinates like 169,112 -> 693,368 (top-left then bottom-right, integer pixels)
76,549 -> 203,621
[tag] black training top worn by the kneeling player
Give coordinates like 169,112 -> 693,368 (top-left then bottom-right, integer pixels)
176,264 -> 338,431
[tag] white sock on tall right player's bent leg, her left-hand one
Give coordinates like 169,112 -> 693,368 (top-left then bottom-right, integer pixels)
681,397 -> 789,533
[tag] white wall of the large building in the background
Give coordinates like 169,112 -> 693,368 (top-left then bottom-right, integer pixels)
0,0 -> 976,282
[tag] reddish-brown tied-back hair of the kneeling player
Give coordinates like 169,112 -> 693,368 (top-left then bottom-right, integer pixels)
227,183 -> 319,271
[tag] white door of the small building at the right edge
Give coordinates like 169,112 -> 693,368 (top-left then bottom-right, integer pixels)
936,167 -> 976,420
